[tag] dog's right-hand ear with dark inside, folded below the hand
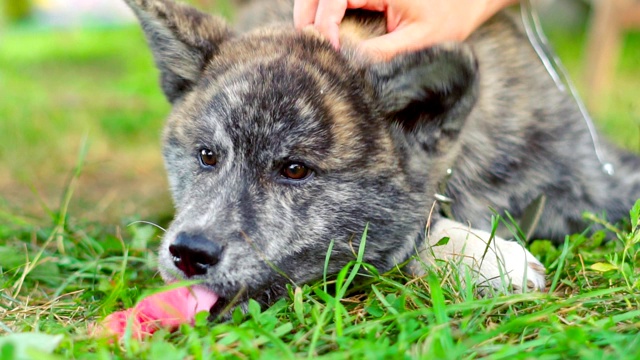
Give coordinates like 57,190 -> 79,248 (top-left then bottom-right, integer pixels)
367,44 -> 478,151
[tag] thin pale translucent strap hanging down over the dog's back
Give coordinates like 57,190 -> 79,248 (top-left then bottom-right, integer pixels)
520,0 -> 615,176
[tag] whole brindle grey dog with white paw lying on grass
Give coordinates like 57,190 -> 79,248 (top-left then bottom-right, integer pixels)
125,0 -> 640,315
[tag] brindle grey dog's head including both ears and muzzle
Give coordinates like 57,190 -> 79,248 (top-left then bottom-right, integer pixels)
127,0 -> 476,316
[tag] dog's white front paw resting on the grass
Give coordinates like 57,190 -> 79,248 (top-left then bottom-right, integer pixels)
421,219 -> 545,292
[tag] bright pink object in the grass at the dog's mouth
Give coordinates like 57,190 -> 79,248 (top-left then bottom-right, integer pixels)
94,286 -> 218,339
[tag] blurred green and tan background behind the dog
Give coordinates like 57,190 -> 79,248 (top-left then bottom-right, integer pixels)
0,0 -> 640,222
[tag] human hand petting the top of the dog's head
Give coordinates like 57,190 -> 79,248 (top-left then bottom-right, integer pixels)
294,0 -> 517,60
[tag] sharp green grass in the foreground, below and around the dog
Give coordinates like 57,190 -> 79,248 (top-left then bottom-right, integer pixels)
0,188 -> 640,360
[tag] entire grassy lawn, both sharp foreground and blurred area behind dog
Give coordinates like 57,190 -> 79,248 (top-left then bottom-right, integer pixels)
0,4 -> 640,360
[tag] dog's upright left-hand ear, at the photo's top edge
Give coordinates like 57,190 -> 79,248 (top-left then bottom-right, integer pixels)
125,0 -> 232,103
